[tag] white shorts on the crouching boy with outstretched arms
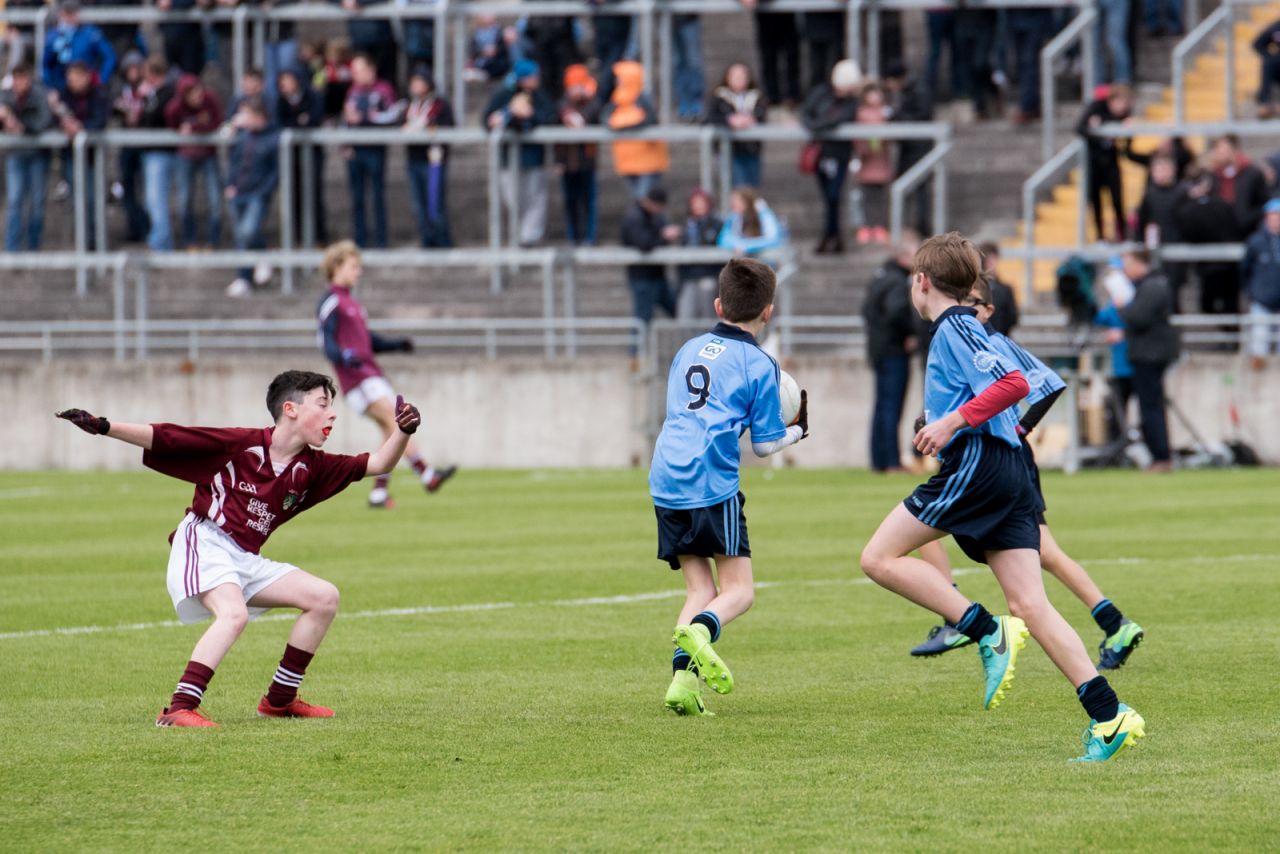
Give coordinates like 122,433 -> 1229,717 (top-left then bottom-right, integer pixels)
168,513 -> 298,622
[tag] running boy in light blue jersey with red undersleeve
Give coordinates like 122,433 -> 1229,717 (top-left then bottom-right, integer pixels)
861,232 -> 1146,762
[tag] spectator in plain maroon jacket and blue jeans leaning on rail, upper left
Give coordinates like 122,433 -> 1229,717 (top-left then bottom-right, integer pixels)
165,74 -> 223,248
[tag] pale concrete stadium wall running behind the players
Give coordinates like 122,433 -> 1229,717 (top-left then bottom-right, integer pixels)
0,353 -> 1280,470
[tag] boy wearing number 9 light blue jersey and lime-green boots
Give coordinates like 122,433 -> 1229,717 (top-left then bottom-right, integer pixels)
649,259 -> 809,714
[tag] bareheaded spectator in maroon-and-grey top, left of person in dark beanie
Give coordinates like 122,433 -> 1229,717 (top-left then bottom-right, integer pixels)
342,54 -> 401,248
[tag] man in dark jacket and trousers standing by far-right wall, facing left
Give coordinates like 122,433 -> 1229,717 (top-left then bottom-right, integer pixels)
1115,248 -> 1179,471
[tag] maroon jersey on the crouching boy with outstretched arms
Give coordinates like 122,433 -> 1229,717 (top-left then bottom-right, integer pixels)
142,424 -> 369,554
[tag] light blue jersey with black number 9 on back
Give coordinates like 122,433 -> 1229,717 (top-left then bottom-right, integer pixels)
649,323 -> 787,510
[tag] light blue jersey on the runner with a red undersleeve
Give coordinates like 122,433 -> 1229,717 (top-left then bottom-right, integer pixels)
924,306 -> 1021,458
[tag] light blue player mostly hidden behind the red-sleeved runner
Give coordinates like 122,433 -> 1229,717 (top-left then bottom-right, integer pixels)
911,278 -> 1143,670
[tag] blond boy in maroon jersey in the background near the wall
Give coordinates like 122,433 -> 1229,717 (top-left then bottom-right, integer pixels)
316,241 -> 458,507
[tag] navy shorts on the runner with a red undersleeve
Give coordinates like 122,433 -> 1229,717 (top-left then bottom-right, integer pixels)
902,433 -> 1041,563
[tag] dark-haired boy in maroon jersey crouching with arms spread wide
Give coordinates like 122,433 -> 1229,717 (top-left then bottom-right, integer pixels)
58,370 -> 421,727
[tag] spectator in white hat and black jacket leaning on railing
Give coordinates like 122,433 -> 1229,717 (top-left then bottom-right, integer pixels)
801,59 -> 863,255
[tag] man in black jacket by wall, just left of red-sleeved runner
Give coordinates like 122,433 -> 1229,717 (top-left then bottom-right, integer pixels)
863,232 -> 920,471
